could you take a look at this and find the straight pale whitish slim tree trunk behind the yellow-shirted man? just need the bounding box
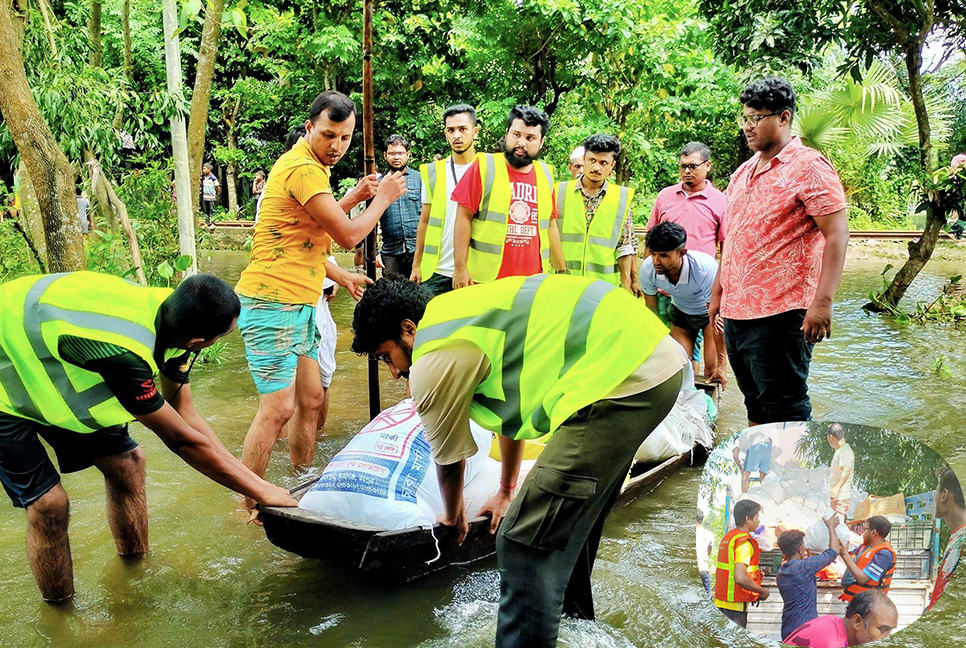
[161,0,200,274]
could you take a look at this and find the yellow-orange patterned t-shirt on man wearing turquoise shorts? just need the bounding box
[235,138,332,306]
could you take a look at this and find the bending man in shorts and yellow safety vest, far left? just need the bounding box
[0,272,296,603]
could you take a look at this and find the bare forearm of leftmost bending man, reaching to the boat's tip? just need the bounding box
[136,404,298,506]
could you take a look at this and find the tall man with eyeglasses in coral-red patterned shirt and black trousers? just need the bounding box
[708,77,849,425]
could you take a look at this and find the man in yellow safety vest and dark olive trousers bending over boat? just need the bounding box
[352,274,687,648]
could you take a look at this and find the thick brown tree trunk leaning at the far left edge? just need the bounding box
[0,1,84,272]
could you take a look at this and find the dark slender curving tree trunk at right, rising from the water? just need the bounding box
[865,39,946,312]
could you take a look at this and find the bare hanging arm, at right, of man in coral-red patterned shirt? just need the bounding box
[802,209,849,344]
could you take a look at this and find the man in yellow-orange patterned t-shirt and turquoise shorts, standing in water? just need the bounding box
[235,91,406,498]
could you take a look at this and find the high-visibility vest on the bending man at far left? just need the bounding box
[0,272,172,433]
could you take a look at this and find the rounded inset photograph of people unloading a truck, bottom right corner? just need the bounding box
[695,421,966,648]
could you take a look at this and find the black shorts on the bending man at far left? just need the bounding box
[0,413,138,508]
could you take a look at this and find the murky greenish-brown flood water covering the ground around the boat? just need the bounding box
[0,253,966,648]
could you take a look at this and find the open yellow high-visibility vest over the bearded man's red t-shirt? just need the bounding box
[466,153,553,283]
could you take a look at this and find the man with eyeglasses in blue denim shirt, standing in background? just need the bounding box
[379,134,423,279]
